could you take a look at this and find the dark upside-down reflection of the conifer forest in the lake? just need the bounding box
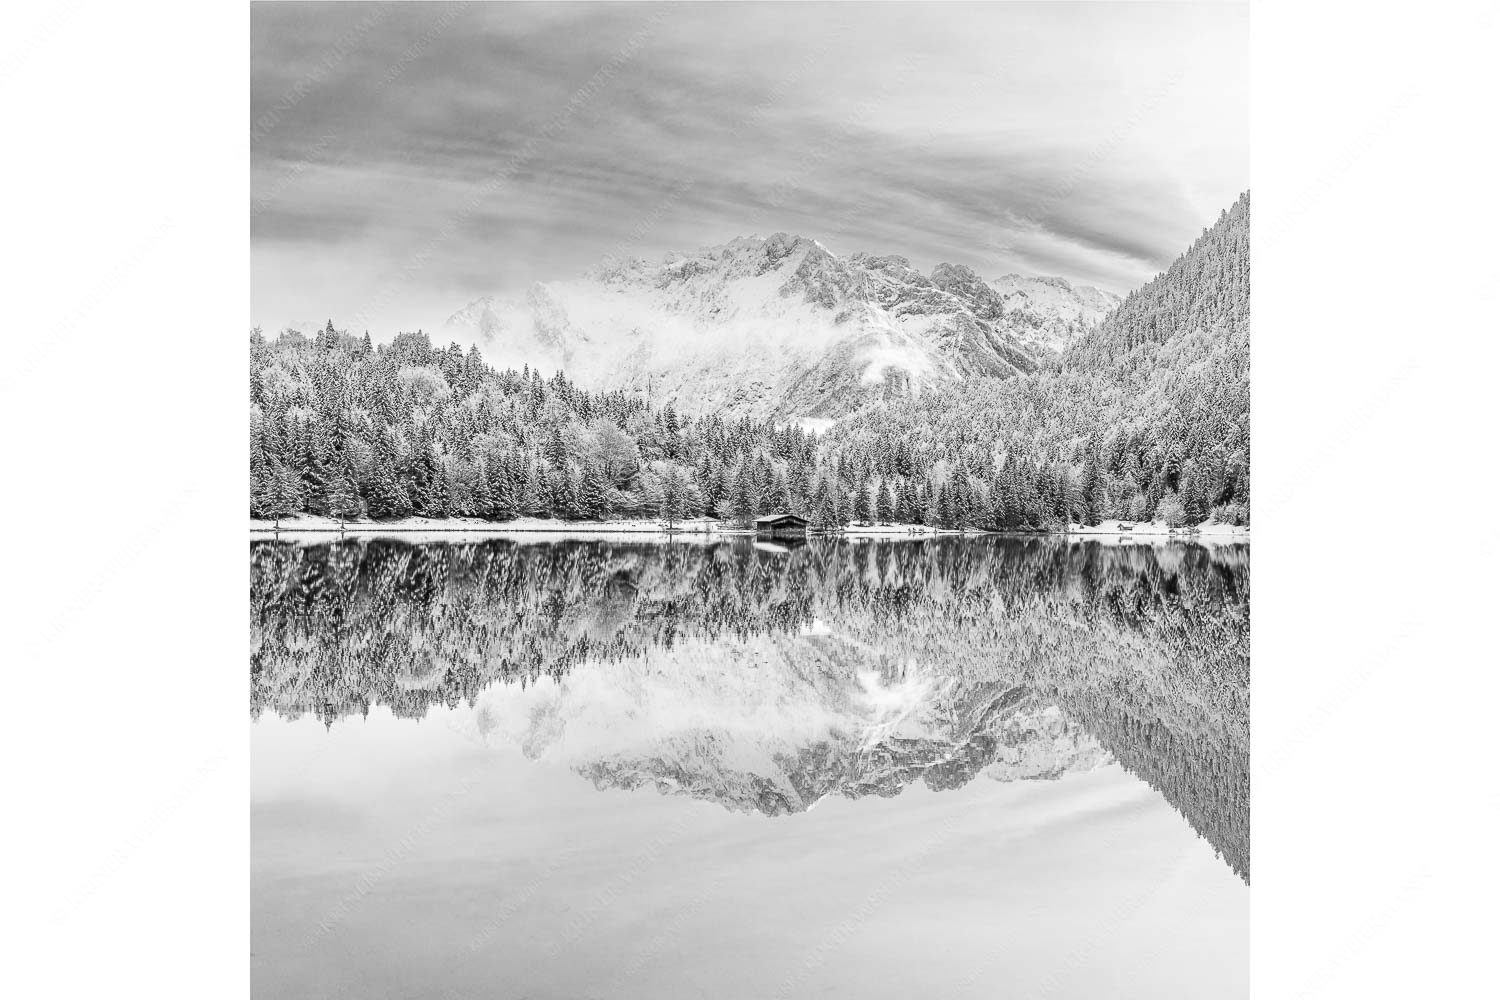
[251,538,1250,874]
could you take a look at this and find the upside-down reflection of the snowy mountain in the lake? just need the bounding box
[462,634,1113,816]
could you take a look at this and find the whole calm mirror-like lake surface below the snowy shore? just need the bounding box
[251,537,1250,1000]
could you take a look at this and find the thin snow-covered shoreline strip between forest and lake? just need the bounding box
[251,516,1250,544]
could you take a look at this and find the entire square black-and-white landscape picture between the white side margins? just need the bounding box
[249,3,1251,999]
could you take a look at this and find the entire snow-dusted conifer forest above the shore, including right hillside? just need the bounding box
[251,192,1250,529]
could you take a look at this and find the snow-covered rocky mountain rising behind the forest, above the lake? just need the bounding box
[440,232,1119,421]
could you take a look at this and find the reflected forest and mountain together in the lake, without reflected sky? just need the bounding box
[251,537,1250,882]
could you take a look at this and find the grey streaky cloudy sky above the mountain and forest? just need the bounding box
[251,3,1250,339]
